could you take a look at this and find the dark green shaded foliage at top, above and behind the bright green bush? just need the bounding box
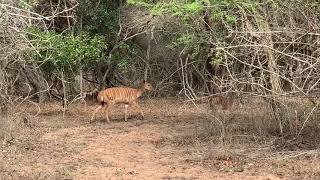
[74,0,132,67]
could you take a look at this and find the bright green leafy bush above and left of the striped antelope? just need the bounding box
[27,28,106,72]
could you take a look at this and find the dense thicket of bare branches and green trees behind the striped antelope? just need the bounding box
[0,0,320,143]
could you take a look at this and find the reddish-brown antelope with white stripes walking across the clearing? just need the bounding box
[90,80,153,123]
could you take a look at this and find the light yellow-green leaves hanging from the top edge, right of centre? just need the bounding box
[128,0,281,64]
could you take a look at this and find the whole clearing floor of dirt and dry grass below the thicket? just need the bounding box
[0,99,320,179]
